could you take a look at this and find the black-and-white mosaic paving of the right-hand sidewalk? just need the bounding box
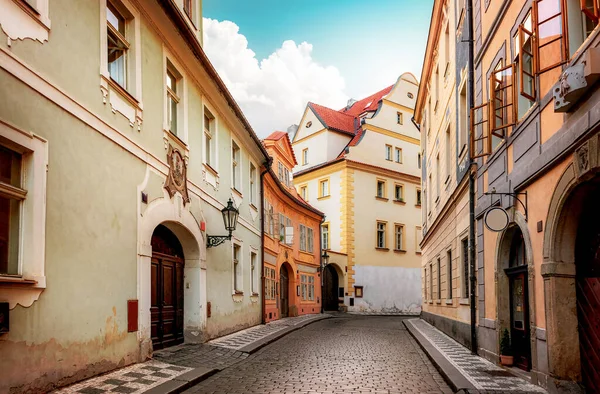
[406,319,546,394]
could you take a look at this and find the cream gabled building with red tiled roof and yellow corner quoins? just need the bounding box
[292,73,421,312]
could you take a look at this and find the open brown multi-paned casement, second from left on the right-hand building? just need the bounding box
[490,63,517,138]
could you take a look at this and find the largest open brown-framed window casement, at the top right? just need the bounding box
[533,0,568,74]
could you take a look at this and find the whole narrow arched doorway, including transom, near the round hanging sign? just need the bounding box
[504,227,531,371]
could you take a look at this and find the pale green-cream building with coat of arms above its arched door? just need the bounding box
[0,0,267,392]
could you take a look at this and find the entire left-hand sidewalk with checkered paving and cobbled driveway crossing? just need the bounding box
[53,314,331,394]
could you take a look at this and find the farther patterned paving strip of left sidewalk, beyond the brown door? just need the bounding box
[208,314,323,350]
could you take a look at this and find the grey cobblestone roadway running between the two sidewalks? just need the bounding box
[187,315,452,394]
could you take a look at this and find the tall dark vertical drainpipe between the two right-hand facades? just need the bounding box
[467,0,477,354]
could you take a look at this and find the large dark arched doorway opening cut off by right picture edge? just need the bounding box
[575,180,600,393]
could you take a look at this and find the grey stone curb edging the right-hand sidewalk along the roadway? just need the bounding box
[402,319,478,393]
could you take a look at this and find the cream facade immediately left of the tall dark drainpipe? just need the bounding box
[415,1,471,346]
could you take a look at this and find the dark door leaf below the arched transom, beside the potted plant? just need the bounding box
[507,266,531,371]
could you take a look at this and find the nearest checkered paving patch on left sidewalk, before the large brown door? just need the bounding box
[52,360,192,394]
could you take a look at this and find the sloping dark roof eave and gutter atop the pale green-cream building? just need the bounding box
[157,0,269,163]
